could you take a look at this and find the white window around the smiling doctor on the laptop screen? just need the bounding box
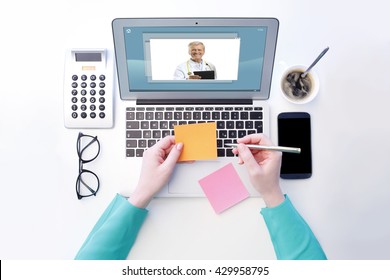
[145,37,240,82]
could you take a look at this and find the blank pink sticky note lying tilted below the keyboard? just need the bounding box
[199,163,249,214]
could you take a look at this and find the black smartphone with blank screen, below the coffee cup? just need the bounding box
[278,112,312,179]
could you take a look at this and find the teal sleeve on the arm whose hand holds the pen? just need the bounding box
[261,196,326,260]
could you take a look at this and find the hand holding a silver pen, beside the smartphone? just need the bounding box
[233,134,284,207]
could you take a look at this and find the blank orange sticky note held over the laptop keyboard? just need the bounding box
[174,122,217,161]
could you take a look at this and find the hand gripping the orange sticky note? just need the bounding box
[129,136,183,208]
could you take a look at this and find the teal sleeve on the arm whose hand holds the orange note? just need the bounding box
[75,194,148,260]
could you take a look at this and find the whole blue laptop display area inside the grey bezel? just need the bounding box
[123,26,267,92]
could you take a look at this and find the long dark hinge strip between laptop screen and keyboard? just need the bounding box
[137,99,253,105]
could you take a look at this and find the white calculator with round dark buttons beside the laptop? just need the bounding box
[64,48,114,128]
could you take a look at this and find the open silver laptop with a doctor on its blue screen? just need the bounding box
[112,18,279,197]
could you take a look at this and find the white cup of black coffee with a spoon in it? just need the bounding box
[280,65,320,104]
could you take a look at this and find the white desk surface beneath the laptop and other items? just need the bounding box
[0,0,390,259]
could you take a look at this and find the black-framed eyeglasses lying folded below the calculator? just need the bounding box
[76,132,100,199]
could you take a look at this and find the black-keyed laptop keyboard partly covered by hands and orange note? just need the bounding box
[126,105,263,157]
